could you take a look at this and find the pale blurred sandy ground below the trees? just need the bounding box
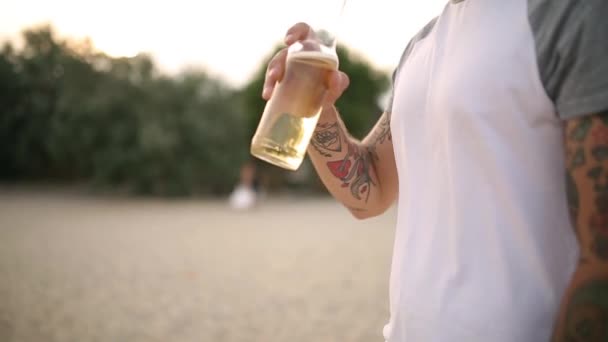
[0,189,395,342]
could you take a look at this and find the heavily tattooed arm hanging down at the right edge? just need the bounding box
[554,111,608,342]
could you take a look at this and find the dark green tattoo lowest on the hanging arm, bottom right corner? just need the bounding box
[556,278,608,342]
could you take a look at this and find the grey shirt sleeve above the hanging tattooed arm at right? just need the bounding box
[528,0,608,119]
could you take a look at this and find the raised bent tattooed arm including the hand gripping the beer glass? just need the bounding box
[262,23,397,219]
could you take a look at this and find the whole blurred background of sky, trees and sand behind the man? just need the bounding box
[0,0,444,341]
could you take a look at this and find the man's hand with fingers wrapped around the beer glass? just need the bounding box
[262,23,349,107]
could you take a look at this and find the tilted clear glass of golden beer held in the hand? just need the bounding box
[251,51,338,170]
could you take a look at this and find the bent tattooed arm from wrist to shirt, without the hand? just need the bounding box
[308,106,397,219]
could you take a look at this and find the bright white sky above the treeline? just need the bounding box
[0,0,447,86]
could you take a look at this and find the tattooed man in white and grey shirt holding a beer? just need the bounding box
[263,0,608,342]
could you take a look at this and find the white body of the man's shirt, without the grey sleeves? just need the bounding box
[384,0,579,342]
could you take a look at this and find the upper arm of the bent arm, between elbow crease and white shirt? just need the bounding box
[362,113,399,206]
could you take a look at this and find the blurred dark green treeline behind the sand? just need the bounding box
[0,26,388,196]
